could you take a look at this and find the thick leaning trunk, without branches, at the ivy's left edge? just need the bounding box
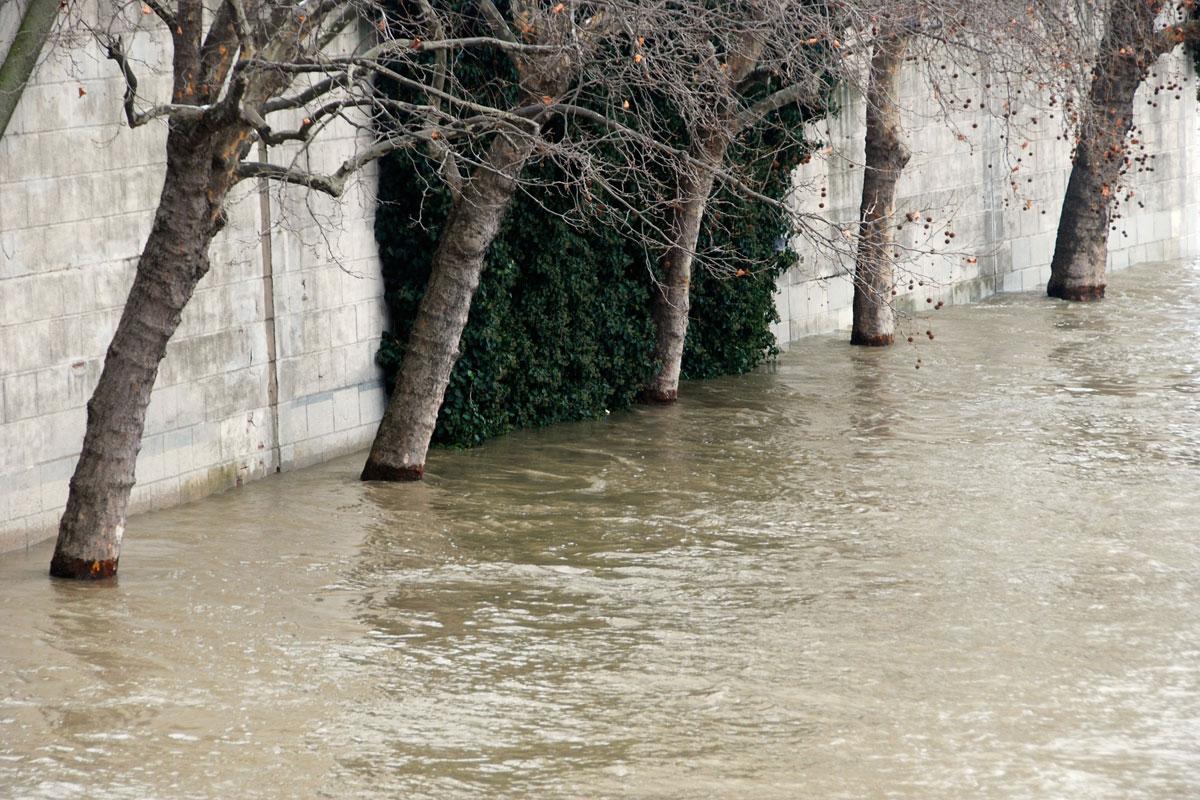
[362,134,534,481]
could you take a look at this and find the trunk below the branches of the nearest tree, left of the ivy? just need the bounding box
[50,130,228,578]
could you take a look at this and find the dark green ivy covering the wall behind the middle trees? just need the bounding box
[376,92,820,446]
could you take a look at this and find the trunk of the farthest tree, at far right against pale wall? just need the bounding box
[1046,1,1162,301]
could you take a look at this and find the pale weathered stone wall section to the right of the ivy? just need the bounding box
[775,48,1200,342]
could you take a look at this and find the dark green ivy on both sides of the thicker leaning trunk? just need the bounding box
[376,160,654,446]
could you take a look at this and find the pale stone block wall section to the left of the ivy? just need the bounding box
[0,20,384,552]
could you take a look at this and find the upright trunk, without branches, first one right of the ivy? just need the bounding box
[850,35,911,347]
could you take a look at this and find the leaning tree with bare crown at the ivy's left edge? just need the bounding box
[362,0,643,481]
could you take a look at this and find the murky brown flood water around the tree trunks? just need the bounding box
[0,265,1200,800]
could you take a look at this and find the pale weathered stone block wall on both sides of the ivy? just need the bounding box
[0,23,1200,552]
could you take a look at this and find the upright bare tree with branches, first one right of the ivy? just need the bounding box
[847,0,1086,347]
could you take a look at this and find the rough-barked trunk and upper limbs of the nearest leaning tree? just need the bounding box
[50,0,274,579]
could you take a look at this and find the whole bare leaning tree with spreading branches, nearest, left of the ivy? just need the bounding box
[50,0,549,578]
